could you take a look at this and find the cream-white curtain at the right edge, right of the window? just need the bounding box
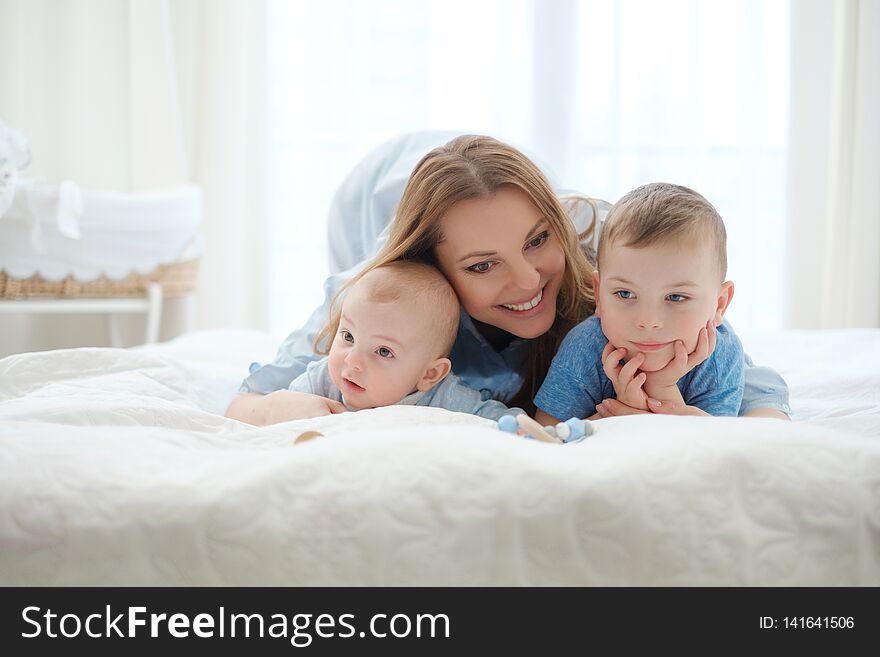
[788,0,880,328]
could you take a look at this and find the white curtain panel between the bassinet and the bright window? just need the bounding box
[170,0,269,328]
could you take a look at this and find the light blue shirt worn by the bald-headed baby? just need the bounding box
[288,358,522,420]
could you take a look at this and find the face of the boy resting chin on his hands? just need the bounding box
[594,243,723,372]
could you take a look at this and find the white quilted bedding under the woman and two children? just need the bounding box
[0,331,880,586]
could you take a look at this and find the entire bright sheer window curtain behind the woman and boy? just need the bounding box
[269,0,789,332]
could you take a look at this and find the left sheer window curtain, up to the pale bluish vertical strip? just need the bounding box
[269,0,532,333]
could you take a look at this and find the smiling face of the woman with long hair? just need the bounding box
[436,186,565,338]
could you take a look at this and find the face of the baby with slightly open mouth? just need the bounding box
[328,285,440,410]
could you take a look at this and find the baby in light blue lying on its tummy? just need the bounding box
[289,262,519,420]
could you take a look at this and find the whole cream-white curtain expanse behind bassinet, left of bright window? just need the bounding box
[0,0,267,354]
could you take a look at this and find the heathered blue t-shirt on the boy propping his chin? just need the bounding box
[535,315,744,420]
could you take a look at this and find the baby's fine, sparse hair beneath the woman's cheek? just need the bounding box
[359,260,461,357]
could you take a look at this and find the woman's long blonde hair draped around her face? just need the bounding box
[315,135,598,412]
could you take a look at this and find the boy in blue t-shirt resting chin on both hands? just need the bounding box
[535,183,743,424]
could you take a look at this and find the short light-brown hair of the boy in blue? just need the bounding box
[598,183,727,281]
